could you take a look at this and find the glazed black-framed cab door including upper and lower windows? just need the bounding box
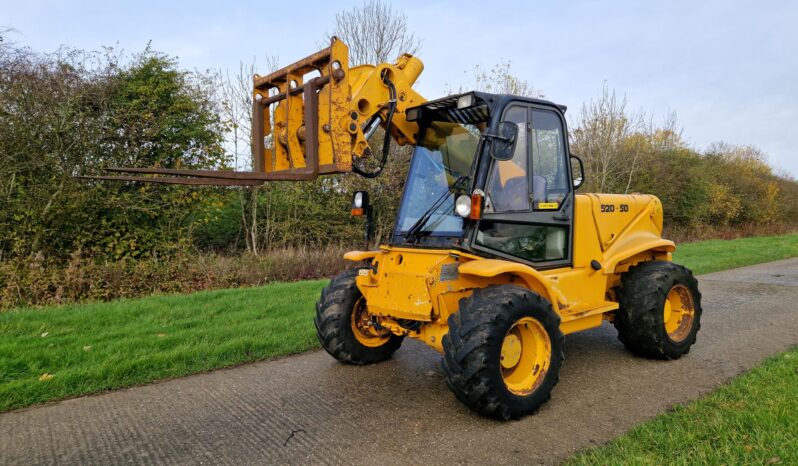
[472,103,574,268]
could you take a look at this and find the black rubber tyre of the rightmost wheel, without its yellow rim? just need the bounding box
[614,261,702,359]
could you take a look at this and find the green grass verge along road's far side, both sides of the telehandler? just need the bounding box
[0,235,798,412]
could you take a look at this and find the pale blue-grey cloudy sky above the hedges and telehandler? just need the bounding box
[6,0,798,177]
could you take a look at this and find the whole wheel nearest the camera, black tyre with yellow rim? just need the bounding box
[442,285,564,420]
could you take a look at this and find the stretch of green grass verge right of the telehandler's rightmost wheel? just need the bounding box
[673,233,798,275]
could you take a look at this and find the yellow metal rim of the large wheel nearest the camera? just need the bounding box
[501,317,551,395]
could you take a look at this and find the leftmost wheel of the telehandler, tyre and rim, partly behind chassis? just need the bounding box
[314,269,403,364]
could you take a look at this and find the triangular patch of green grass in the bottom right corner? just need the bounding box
[565,348,798,465]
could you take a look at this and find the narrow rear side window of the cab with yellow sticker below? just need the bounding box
[529,109,570,209]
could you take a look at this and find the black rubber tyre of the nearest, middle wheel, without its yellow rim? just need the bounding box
[442,285,565,420]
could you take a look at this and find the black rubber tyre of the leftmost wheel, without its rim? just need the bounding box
[313,269,404,365]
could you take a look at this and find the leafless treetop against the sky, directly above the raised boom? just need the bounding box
[328,0,421,66]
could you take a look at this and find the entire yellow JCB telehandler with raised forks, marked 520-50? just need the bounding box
[99,38,701,419]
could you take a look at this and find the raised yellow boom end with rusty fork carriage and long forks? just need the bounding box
[84,37,426,186]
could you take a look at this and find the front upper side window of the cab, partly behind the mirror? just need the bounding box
[485,106,529,212]
